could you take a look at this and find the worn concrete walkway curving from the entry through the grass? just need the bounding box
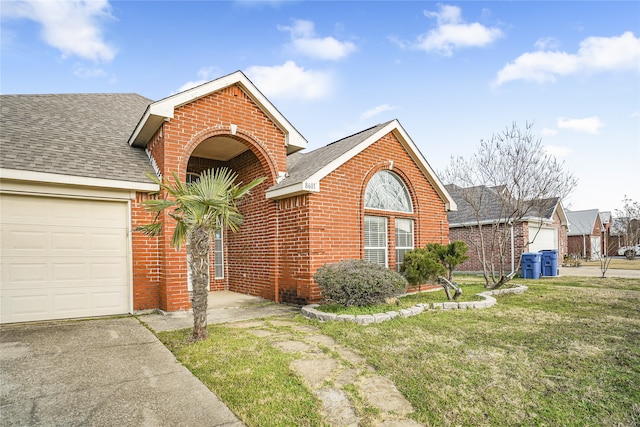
[139,292,421,427]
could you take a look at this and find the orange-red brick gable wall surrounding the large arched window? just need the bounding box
[278,133,449,302]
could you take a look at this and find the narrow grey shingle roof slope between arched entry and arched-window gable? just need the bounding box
[270,121,391,190]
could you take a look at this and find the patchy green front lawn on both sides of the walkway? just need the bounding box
[159,277,640,426]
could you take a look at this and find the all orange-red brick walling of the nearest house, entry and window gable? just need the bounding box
[133,86,449,311]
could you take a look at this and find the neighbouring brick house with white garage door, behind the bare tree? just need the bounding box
[446,184,568,272]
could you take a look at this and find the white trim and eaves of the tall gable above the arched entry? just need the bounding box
[129,71,307,153]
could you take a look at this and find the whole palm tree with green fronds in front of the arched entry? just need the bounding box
[136,168,265,341]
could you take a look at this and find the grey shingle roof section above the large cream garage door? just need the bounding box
[0,94,157,190]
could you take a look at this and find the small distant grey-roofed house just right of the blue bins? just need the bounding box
[567,209,603,260]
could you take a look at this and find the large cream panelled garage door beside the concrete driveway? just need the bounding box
[0,194,130,323]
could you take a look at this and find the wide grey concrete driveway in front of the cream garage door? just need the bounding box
[0,317,244,427]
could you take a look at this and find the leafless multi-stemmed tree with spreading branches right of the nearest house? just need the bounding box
[442,123,577,288]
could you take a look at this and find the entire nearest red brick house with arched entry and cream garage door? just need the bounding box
[0,72,455,322]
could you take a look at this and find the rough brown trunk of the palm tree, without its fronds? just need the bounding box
[188,226,211,341]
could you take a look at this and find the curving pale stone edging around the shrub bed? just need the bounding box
[302,285,529,325]
